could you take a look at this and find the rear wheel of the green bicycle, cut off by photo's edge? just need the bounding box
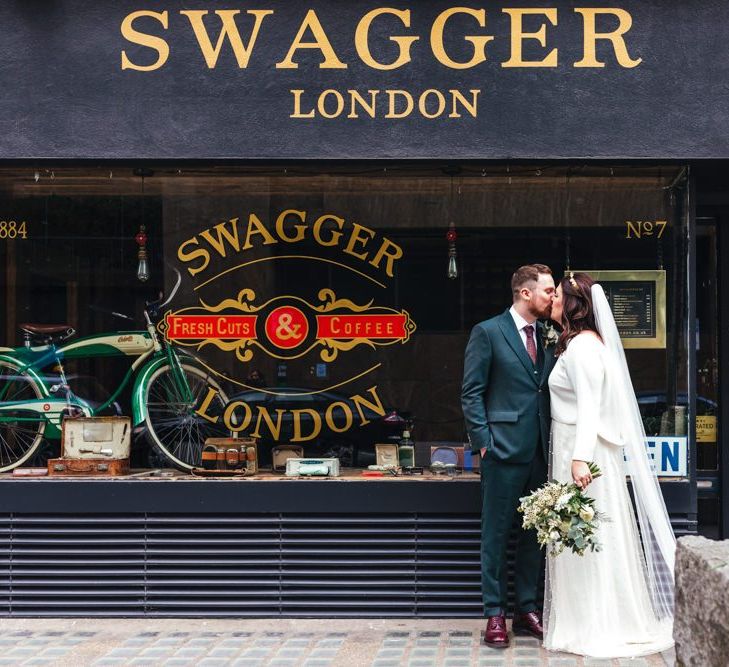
[0,359,46,472]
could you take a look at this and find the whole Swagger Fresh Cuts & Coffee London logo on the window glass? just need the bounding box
[158,209,416,442]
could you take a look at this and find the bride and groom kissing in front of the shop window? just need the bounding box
[461,264,675,658]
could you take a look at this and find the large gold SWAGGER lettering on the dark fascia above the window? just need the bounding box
[119,6,642,71]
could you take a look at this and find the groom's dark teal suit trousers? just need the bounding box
[481,444,547,617]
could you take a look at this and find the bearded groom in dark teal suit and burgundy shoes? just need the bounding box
[461,264,555,648]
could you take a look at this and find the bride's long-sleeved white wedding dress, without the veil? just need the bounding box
[544,332,673,658]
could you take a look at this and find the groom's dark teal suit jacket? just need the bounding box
[461,310,555,463]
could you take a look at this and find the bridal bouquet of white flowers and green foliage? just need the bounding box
[519,463,608,556]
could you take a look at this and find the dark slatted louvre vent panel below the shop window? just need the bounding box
[0,514,695,618]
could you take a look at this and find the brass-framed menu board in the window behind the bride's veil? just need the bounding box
[575,270,666,348]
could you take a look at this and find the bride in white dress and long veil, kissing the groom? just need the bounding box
[544,273,676,658]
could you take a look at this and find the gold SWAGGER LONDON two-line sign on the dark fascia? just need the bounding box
[119,3,642,122]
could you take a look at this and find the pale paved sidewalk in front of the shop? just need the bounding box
[0,619,675,667]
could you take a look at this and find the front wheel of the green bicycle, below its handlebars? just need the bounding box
[144,362,231,470]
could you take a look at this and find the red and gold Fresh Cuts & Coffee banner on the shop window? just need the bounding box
[159,289,416,362]
